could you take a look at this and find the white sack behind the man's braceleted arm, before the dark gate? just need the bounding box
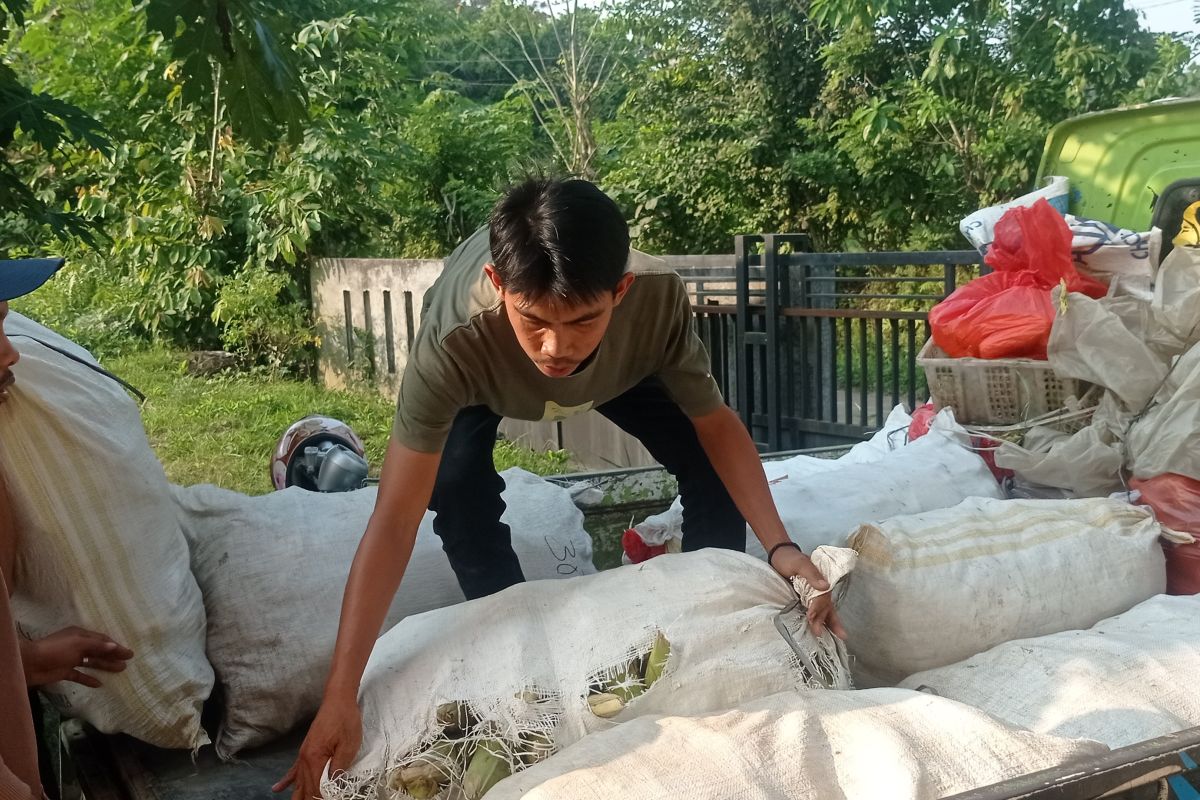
[634,415,1004,559]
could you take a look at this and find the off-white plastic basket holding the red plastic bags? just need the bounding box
[917,339,1091,425]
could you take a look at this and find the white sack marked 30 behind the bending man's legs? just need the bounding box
[173,469,595,758]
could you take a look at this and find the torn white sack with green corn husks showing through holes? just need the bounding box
[323,548,852,800]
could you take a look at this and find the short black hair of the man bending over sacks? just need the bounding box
[488,178,629,305]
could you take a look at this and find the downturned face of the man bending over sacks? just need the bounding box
[484,264,634,378]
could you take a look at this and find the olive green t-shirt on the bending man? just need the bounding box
[392,228,724,452]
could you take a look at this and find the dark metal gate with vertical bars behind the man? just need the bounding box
[676,234,983,452]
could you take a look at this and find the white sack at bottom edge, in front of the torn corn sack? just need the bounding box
[487,688,1105,800]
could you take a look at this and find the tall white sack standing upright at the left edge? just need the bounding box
[0,313,212,748]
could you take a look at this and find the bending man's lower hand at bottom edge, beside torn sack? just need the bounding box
[271,697,362,800]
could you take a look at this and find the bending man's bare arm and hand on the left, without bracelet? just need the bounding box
[275,438,442,800]
